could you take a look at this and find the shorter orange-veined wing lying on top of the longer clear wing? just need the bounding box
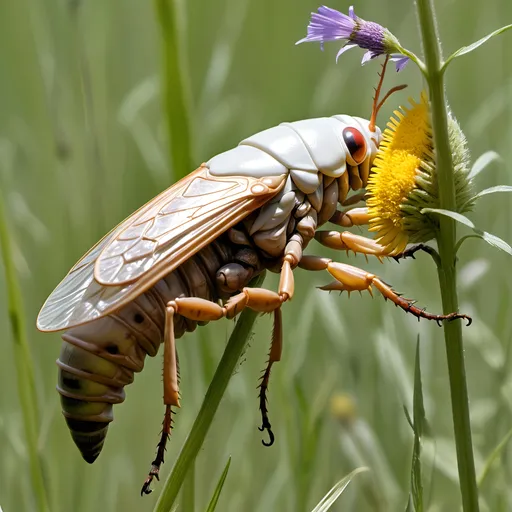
[94,167,284,286]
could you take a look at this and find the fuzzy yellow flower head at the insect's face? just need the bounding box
[366,93,471,255]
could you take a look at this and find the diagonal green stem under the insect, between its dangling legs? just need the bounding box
[154,275,265,512]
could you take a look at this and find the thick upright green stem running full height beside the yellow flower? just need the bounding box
[417,0,479,512]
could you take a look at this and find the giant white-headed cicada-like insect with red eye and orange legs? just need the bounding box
[37,62,463,493]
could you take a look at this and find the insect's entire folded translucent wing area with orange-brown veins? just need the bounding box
[37,167,286,331]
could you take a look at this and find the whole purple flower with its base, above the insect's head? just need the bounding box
[296,6,409,71]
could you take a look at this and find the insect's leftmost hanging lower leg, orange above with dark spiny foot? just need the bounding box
[140,302,180,496]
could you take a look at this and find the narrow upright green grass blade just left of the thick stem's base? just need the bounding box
[411,336,425,512]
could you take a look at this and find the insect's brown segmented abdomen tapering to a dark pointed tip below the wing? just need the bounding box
[57,240,232,463]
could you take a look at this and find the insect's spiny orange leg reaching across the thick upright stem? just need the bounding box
[299,256,471,325]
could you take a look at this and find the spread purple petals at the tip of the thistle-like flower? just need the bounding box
[296,6,356,44]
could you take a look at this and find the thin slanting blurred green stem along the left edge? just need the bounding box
[0,194,50,512]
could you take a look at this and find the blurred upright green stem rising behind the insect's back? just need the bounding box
[155,0,193,181]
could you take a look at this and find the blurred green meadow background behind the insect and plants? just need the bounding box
[0,0,512,512]
